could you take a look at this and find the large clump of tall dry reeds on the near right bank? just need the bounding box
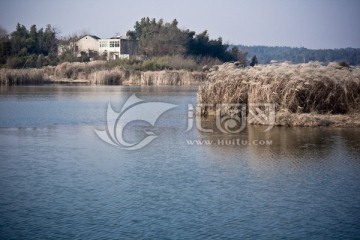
[198,62,360,126]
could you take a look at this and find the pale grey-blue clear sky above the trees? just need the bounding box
[0,0,360,49]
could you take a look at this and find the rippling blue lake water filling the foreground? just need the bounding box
[0,85,360,239]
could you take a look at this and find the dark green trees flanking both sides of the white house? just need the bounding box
[0,17,246,68]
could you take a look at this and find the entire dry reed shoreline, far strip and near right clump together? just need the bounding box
[0,62,360,128]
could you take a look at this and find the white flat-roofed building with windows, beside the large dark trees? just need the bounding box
[99,37,137,60]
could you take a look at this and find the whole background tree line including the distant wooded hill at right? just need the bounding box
[0,17,360,68]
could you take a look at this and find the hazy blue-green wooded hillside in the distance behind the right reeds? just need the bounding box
[237,45,360,65]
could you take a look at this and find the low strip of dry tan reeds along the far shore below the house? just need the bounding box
[0,57,206,85]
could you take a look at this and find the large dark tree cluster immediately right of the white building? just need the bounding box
[127,17,246,65]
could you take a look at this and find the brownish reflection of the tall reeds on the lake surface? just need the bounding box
[197,117,360,170]
